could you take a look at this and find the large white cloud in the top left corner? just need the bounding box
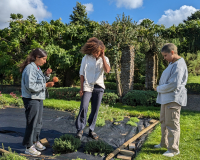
[0,0,51,29]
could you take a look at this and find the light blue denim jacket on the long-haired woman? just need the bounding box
[21,62,50,100]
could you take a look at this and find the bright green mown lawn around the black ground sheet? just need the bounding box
[0,95,200,160]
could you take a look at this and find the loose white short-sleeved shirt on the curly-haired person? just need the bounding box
[79,54,110,92]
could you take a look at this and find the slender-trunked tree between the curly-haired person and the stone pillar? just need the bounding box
[94,14,137,97]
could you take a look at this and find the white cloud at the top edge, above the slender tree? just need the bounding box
[114,0,143,9]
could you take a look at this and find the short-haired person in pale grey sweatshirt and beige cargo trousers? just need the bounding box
[154,43,188,157]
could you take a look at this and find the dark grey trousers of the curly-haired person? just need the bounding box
[75,85,104,131]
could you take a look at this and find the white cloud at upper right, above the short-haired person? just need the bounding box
[158,5,198,27]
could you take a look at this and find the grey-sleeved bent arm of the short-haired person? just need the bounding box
[157,68,184,93]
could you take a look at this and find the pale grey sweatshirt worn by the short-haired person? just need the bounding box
[156,58,188,106]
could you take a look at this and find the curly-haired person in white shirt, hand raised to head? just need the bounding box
[75,37,110,139]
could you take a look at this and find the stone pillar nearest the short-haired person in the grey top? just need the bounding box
[145,50,157,90]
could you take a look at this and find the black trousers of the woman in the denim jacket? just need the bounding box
[22,98,43,147]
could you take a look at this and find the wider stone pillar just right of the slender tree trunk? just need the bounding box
[121,46,135,96]
